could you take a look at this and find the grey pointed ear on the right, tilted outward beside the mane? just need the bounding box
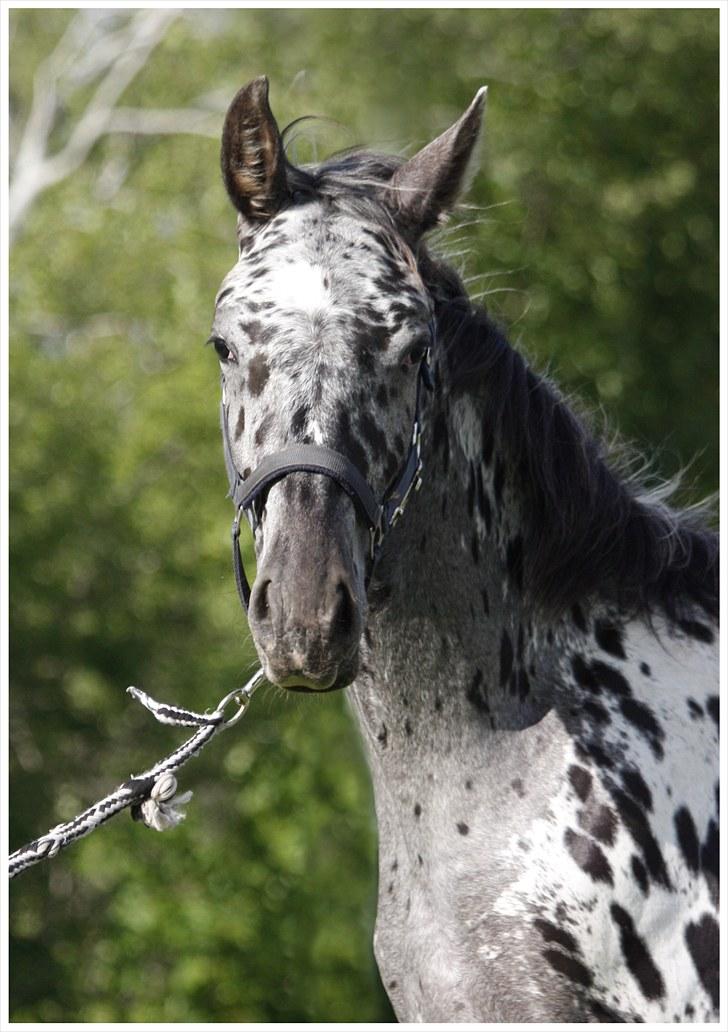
[386,86,487,237]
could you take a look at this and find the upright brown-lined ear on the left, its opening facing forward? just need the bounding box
[220,75,289,222]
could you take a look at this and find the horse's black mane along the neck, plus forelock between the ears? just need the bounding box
[297,152,719,620]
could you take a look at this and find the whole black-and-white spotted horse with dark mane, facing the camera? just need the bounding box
[211,77,719,1023]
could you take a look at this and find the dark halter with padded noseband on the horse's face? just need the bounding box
[220,348,433,612]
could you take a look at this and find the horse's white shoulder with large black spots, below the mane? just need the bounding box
[512,606,719,1021]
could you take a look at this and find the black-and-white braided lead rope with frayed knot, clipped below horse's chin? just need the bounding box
[8,670,265,878]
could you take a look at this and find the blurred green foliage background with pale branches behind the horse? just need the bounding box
[9,9,719,1023]
